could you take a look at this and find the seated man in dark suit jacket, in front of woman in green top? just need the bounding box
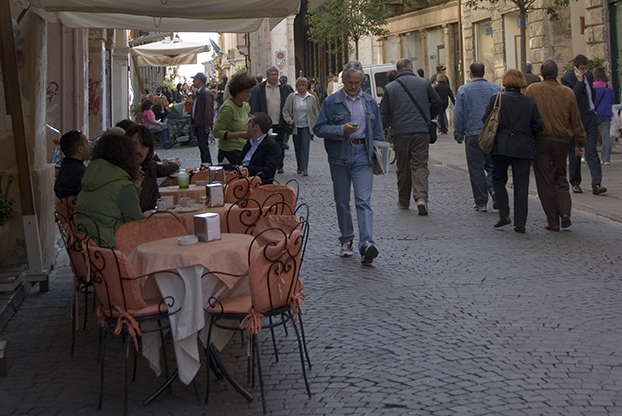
[238,112,281,183]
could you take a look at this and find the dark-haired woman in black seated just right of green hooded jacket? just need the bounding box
[125,124,179,212]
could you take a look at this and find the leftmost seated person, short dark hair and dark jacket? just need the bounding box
[54,130,91,199]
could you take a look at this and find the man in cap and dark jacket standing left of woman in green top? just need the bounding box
[192,72,214,165]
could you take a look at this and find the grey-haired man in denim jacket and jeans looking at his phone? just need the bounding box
[313,61,384,265]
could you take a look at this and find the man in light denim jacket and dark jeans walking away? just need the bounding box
[454,61,503,212]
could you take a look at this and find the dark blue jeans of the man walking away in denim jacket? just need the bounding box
[464,136,494,205]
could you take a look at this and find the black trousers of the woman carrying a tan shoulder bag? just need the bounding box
[492,155,531,227]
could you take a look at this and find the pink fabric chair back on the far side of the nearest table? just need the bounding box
[114,217,188,256]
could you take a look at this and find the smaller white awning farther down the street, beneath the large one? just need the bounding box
[131,41,211,66]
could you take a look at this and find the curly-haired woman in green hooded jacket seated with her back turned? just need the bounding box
[76,134,145,247]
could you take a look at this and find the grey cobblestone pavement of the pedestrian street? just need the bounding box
[0,140,622,416]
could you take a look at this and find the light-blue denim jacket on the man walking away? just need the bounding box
[454,78,501,142]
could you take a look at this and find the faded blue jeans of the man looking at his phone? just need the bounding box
[330,144,375,252]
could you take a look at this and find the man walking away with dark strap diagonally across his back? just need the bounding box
[380,58,442,215]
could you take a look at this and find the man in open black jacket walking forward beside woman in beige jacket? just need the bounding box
[251,66,294,173]
